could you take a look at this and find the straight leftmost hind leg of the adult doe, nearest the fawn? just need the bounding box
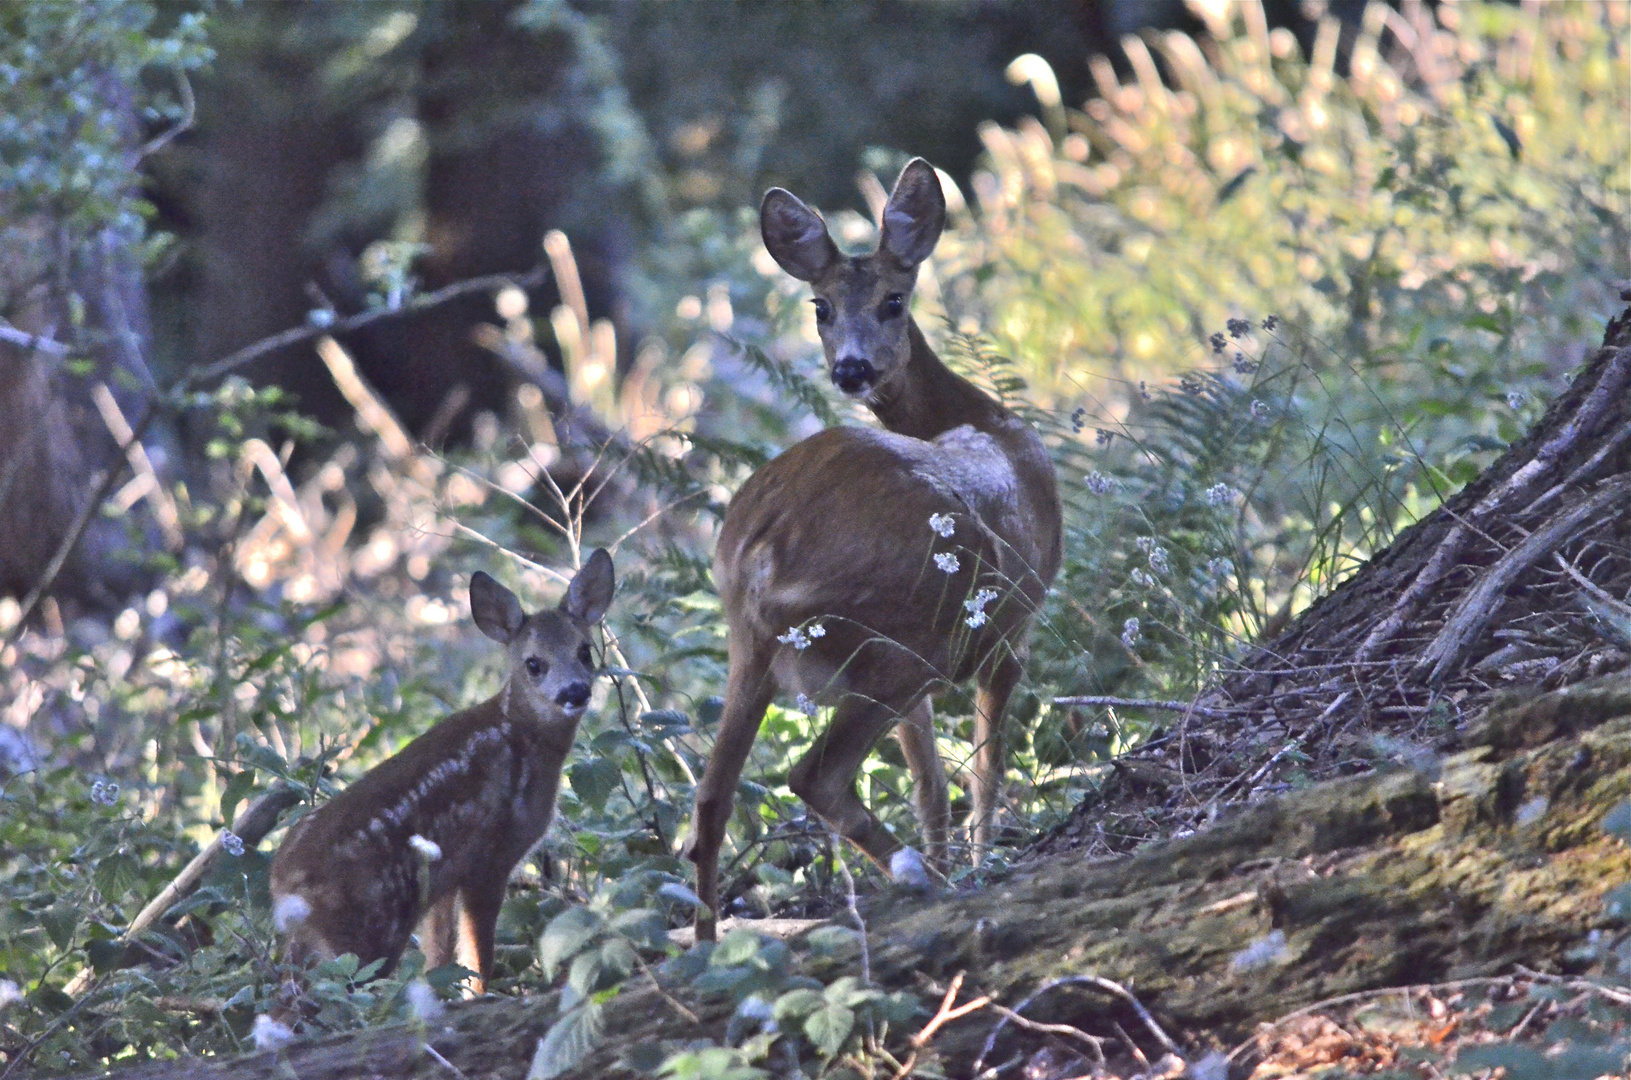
[685,656,775,941]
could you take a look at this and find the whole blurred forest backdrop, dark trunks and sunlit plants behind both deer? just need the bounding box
[0,0,1631,1069]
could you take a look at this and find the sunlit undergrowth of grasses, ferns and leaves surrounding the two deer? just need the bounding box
[0,5,1631,1077]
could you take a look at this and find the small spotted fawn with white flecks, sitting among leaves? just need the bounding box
[272,551,613,994]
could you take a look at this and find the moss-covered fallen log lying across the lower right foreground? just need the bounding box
[101,674,1631,1080]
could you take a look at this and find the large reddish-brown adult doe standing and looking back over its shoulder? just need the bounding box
[687,158,1060,940]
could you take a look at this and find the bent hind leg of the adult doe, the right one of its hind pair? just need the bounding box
[788,695,900,873]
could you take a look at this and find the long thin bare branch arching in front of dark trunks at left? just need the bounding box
[0,268,546,644]
